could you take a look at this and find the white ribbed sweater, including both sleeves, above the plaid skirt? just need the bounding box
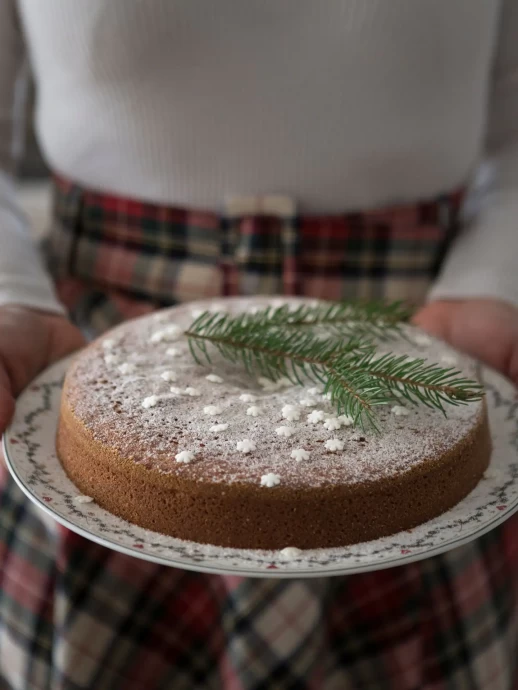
[0,0,518,309]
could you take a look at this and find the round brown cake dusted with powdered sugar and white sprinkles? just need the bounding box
[57,298,491,550]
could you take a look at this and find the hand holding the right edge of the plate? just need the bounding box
[413,299,518,385]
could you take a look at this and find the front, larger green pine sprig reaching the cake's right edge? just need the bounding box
[186,312,483,428]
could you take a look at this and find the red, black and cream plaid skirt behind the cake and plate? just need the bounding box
[0,181,518,690]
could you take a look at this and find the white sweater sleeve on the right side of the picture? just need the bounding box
[429,0,518,305]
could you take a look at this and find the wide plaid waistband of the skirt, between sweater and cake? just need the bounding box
[49,177,463,304]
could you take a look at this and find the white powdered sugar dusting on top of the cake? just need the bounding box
[68,298,483,487]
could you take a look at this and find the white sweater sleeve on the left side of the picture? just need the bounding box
[0,0,64,313]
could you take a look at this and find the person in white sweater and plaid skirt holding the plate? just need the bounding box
[0,0,518,690]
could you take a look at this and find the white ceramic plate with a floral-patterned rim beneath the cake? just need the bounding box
[3,360,518,577]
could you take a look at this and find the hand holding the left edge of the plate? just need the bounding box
[0,306,85,436]
